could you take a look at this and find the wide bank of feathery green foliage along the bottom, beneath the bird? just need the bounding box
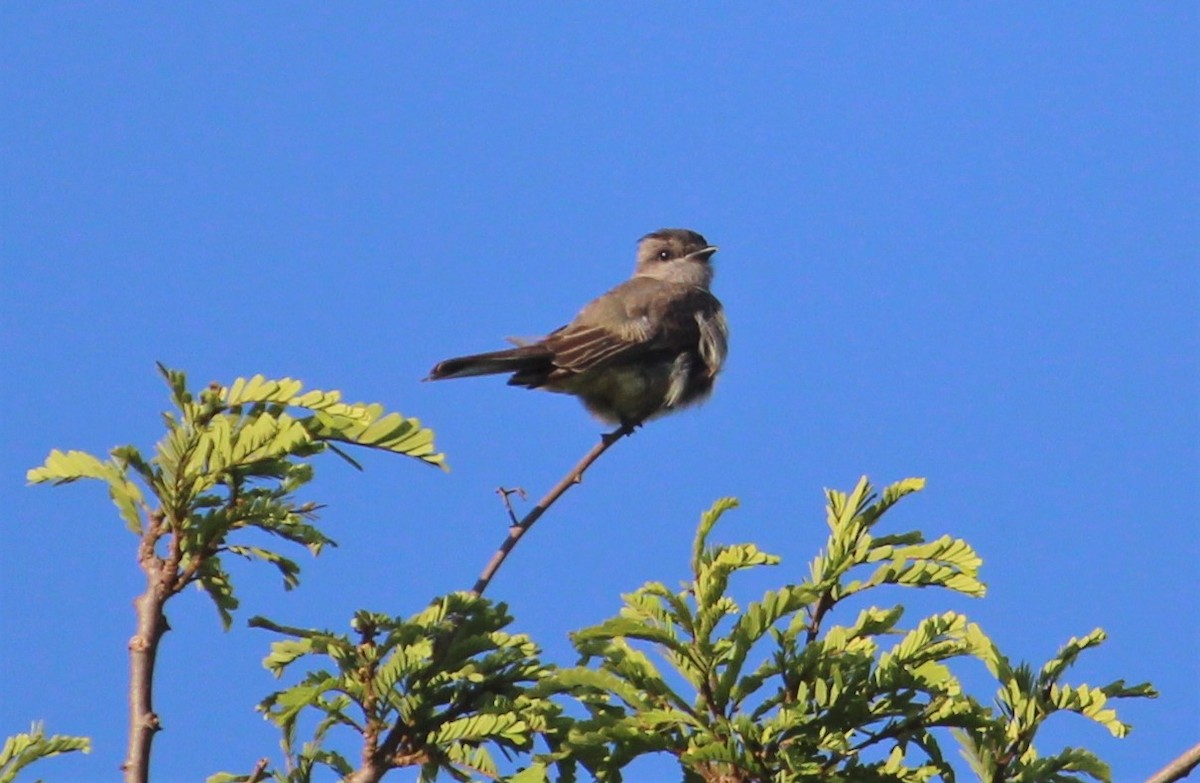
[231,478,1153,783]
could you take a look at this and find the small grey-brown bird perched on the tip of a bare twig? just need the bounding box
[426,228,728,426]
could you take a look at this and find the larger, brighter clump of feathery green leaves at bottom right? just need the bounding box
[537,478,1148,783]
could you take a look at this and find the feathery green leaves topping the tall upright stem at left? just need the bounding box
[28,365,445,627]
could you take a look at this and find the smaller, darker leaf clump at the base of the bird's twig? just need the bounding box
[225,593,558,783]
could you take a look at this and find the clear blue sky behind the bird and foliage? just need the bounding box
[0,2,1200,781]
